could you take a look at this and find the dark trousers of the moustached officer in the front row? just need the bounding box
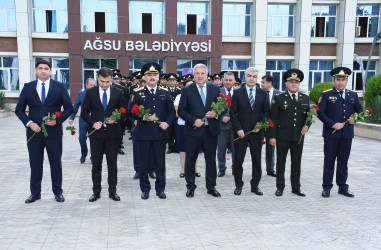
[136,140,166,192]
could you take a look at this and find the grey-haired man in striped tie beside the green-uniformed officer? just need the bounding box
[230,67,270,195]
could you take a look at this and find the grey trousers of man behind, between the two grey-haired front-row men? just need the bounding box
[217,128,235,171]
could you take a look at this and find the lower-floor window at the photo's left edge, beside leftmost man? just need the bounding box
[0,57,19,91]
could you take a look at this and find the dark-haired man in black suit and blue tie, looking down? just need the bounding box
[81,68,126,202]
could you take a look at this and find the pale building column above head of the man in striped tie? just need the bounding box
[250,0,268,75]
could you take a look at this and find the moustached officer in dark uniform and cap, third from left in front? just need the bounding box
[128,63,175,200]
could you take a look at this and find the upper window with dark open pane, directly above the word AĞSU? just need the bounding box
[81,0,118,33]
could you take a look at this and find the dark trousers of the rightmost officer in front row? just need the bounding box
[323,138,352,190]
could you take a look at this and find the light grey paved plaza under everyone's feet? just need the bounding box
[0,113,381,249]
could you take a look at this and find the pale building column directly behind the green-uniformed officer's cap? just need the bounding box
[295,0,312,91]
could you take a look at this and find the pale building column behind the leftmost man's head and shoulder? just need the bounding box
[15,0,34,91]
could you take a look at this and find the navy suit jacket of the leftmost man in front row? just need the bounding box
[15,79,73,138]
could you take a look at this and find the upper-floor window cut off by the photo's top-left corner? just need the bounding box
[0,0,16,31]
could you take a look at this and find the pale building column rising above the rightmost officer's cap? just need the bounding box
[336,0,357,88]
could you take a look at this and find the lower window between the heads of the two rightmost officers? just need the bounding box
[308,60,333,90]
